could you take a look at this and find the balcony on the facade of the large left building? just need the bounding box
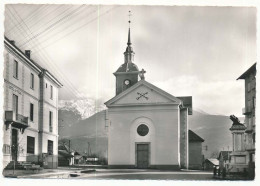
[5,111,29,133]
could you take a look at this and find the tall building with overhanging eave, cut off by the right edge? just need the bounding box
[237,63,256,179]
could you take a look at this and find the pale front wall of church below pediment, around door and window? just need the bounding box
[108,105,179,168]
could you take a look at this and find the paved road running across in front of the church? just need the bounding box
[75,169,214,180]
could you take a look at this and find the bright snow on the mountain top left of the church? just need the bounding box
[59,99,106,119]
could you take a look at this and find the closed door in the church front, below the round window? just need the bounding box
[136,144,149,169]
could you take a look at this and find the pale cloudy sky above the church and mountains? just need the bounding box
[5,4,256,116]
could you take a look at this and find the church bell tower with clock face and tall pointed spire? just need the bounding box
[114,11,143,95]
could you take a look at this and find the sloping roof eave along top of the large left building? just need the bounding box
[4,37,63,87]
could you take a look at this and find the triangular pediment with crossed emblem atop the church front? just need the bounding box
[105,80,181,107]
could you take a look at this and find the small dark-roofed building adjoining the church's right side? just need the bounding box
[189,130,204,169]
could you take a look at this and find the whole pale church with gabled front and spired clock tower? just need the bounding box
[105,21,192,170]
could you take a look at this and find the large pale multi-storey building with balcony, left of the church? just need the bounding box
[3,38,62,168]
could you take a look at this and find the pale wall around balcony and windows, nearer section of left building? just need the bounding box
[3,48,39,167]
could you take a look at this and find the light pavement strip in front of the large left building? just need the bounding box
[3,167,95,178]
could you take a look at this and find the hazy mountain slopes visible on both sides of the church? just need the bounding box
[59,99,242,158]
